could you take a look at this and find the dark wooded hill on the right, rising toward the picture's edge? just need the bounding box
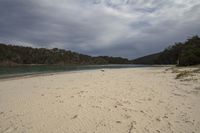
[132,36,200,66]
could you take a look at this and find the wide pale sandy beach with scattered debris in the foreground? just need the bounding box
[0,67,200,133]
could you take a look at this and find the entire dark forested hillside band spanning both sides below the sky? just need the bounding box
[0,36,200,66]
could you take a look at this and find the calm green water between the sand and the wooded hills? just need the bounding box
[0,64,146,78]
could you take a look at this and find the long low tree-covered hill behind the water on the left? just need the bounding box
[0,44,131,65]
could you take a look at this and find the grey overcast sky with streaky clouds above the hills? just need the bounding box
[0,0,200,59]
